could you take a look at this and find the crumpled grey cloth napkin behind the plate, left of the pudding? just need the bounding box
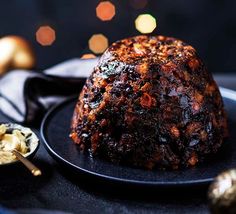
[0,58,98,123]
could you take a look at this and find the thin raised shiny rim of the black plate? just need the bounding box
[40,95,236,187]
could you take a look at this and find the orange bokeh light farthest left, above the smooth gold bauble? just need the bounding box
[36,26,56,46]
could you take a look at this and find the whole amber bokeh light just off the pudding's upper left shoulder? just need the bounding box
[89,34,108,54]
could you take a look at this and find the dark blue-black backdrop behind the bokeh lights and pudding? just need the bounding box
[0,0,236,73]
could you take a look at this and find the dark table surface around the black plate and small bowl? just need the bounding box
[0,74,236,213]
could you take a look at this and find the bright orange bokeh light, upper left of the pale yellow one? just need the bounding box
[96,1,116,21]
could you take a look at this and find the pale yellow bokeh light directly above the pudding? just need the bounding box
[135,14,157,33]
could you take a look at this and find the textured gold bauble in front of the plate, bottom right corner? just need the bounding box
[208,169,236,214]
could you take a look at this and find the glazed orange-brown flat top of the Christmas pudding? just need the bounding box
[102,35,196,64]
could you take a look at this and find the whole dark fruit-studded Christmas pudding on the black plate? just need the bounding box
[70,36,227,169]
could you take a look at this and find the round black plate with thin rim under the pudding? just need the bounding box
[41,93,236,186]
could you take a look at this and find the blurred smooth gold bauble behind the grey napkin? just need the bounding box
[0,36,35,76]
